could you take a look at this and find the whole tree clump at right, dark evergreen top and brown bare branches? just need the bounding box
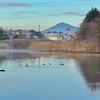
[76,7,100,43]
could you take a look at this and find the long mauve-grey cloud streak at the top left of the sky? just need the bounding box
[0,2,33,7]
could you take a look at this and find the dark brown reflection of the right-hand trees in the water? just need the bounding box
[78,56,100,91]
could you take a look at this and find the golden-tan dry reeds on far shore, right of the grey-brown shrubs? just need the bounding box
[27,41,100,52]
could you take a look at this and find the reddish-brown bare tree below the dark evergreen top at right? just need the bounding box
[76,22,98,42]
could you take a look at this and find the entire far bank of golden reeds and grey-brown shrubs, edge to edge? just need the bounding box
[0,39,100,52]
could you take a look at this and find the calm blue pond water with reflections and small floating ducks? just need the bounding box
[0,50,100,100]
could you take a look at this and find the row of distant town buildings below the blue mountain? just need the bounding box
[3,29,75,40]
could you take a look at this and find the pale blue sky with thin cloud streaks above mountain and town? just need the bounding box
[0,0,100,31]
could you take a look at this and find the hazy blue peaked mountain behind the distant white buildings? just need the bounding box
[43,22,79,34]
